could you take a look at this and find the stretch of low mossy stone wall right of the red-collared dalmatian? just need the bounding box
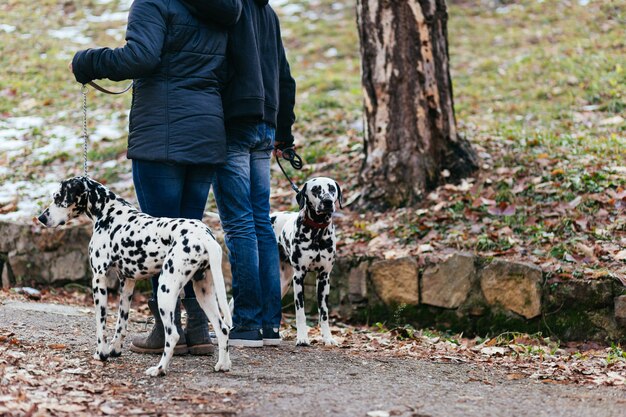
[307,253,626,342]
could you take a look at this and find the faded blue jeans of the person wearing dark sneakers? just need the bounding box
[213,122,281,330]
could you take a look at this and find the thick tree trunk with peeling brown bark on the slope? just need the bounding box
[357,0,478,208]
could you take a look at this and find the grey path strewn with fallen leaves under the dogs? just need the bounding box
[0,301,626,417]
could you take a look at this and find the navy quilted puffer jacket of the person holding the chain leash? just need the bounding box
[72,0,242,164]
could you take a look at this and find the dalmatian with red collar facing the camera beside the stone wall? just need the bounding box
[271,177,342,346]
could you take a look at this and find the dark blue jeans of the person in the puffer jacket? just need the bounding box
[133,159,215,299]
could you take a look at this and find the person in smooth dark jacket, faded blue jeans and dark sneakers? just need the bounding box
[187,0,296,347]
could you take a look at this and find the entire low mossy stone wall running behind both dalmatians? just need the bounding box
[0,222,626,342]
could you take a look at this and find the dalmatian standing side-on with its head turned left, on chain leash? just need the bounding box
[38,177,232,376]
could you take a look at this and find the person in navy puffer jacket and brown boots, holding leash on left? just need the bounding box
[70,0,242,354]
